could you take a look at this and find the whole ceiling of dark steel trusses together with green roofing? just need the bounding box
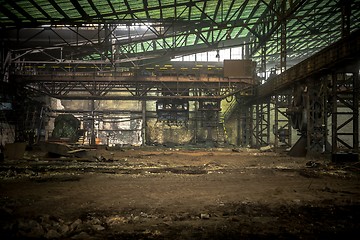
[0,0,360,71]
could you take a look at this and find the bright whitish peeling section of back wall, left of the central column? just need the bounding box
[46,99,143,146]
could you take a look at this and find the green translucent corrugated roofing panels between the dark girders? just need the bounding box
[0,0,360,66]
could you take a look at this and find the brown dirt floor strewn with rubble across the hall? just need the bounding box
[0,147,360,239]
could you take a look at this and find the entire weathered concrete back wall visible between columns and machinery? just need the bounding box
[46,99,360,146]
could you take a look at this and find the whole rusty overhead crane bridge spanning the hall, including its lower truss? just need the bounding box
[12,63,257,101]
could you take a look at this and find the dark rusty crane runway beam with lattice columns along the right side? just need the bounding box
[247,31,360,156]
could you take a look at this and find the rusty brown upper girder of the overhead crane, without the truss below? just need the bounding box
[14,62,253,84]
